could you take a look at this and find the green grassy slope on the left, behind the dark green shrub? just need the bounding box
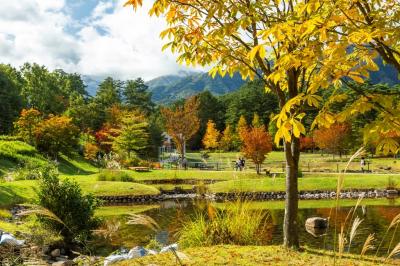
[0,141,160,207]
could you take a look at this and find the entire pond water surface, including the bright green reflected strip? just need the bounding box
[94,199,400,255]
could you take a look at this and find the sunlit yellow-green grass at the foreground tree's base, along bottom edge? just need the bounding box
[116,245,399,266]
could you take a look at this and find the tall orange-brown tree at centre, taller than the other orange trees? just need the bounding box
[161,97,200,157]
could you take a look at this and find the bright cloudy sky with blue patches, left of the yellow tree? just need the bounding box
[0,0,196,80]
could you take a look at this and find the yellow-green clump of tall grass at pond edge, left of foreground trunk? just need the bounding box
[179,201,267,247]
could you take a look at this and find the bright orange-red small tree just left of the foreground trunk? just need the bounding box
[242,126,272,174]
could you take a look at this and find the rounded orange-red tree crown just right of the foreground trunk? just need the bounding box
[314,123,351,156]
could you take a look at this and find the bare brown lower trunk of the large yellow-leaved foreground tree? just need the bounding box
[283,136,300,249]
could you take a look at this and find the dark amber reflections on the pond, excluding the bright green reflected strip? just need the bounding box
[99,200,400,254]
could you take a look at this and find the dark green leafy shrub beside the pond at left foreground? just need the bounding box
[37,166,99,245]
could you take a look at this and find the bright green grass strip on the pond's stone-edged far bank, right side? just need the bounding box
[208,174,400,192]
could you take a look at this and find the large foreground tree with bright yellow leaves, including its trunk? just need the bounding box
[126,0,397,248]
